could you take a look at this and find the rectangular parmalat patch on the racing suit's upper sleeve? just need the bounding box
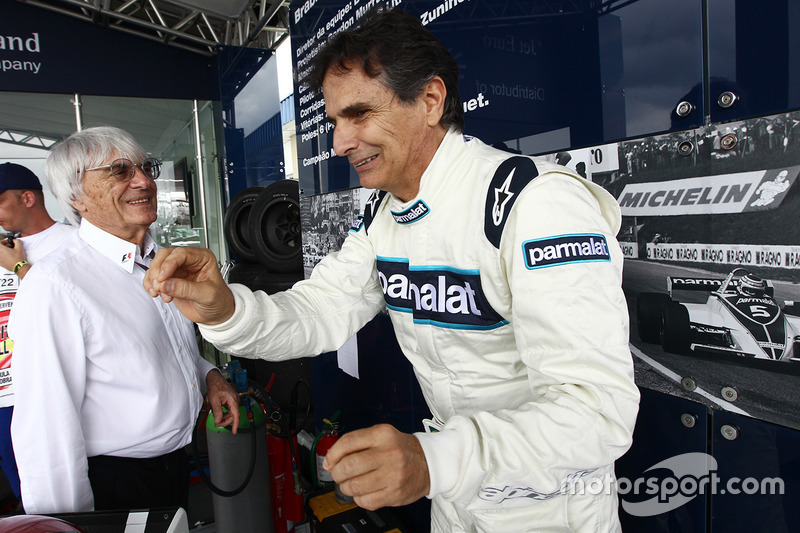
[522,233,611,269]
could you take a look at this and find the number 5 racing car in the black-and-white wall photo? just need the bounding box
[636,268,800,362]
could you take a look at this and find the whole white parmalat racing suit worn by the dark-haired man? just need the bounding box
[201,132,639,532]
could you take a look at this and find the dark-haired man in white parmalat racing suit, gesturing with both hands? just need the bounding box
[144,6,639,532]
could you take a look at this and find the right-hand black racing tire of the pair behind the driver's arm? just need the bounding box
[250,180,303,273]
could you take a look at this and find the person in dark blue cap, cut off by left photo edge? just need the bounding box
[0,163,74,510]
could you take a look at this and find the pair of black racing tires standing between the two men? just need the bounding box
[224,180,303,293]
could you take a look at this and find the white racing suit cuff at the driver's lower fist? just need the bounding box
[414,429,464,498]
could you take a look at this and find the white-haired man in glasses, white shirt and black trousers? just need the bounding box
[9,127,239,514]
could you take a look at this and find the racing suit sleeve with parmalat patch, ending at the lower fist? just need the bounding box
[416,174,639,508]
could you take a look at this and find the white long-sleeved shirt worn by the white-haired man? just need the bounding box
[9,220,215,513]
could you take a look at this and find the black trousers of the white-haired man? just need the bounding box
[89,448,189,512]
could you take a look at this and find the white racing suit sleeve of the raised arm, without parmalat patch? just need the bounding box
[200,228,384,360]
